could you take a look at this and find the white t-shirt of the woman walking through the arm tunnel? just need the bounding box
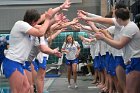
[62,41,80,60]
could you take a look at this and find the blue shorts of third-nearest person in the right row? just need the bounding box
[108,54,116,76]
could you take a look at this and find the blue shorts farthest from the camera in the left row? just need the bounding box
[33,57,47,72]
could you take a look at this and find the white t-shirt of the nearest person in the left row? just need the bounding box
[6,21,32,63]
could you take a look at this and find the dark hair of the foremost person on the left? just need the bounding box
[23,9,40,25]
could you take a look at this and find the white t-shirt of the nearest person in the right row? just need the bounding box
[122,22,140,60]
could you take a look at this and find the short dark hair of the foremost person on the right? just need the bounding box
[115,8,130,21]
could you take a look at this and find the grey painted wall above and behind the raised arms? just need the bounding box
[0,0,100,33]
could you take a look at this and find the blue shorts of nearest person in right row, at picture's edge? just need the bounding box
[126,58,140,74]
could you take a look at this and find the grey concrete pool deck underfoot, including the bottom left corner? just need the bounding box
[0,64,99,93]
